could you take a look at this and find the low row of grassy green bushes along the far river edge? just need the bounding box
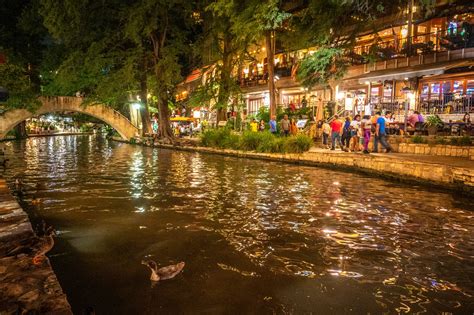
[201,128,313,153]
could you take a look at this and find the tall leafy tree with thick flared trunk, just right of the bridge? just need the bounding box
[124,0,199,139]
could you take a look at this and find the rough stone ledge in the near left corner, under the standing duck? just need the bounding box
[0,179,72,314]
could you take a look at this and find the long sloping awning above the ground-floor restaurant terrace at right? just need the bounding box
[350,59,474,84]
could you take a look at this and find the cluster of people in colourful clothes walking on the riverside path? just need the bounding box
[322,112,392,154]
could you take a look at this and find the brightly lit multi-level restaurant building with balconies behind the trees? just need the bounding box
[177,1,474,121]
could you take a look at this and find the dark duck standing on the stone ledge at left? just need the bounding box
[7,227,56,265]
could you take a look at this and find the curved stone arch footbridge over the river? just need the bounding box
[0,96,139,140]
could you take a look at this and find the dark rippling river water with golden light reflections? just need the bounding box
[5,136,474,314]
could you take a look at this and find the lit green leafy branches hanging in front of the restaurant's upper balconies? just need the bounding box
[291,0,433,88]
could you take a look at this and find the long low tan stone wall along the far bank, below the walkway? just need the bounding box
[113,138,474,196]
